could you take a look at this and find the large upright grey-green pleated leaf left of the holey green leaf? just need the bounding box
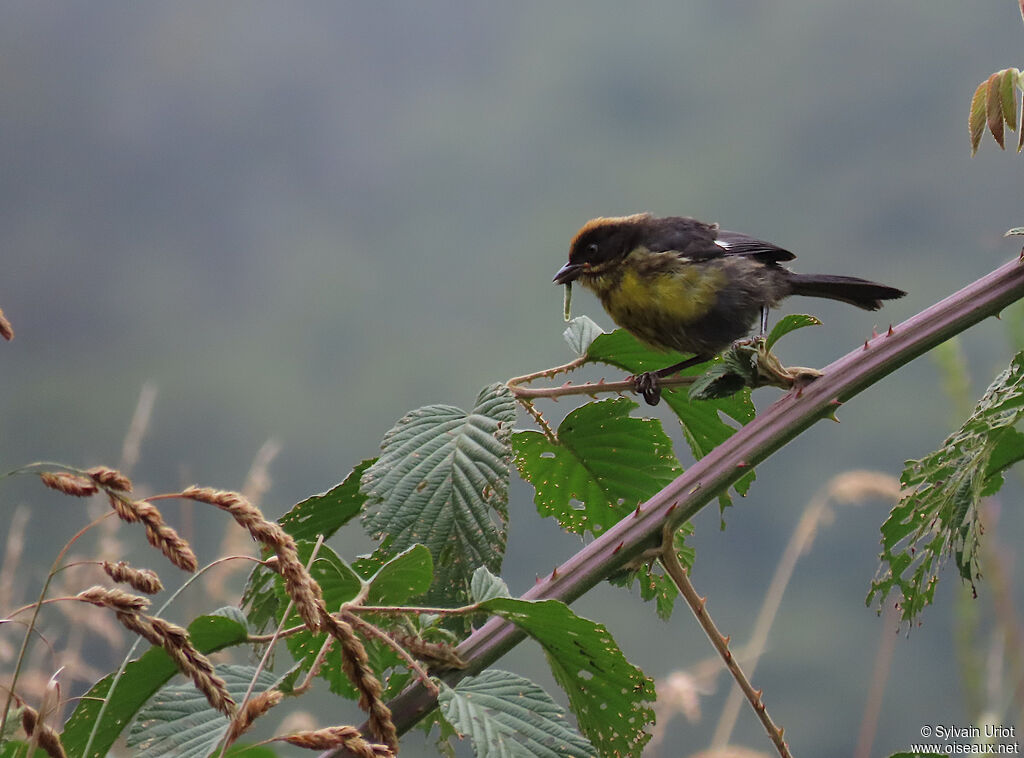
[361,384,515,601]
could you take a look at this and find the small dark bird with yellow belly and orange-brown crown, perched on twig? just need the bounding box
[554,213,906,406]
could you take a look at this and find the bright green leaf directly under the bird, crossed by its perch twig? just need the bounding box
[587,329,754,508]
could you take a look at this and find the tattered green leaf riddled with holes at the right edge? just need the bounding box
[867,352,1024,622]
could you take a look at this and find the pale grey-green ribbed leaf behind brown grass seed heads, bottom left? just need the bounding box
[126,666,278,758]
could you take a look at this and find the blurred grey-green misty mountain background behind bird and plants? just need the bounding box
[0,0,1024,756]
